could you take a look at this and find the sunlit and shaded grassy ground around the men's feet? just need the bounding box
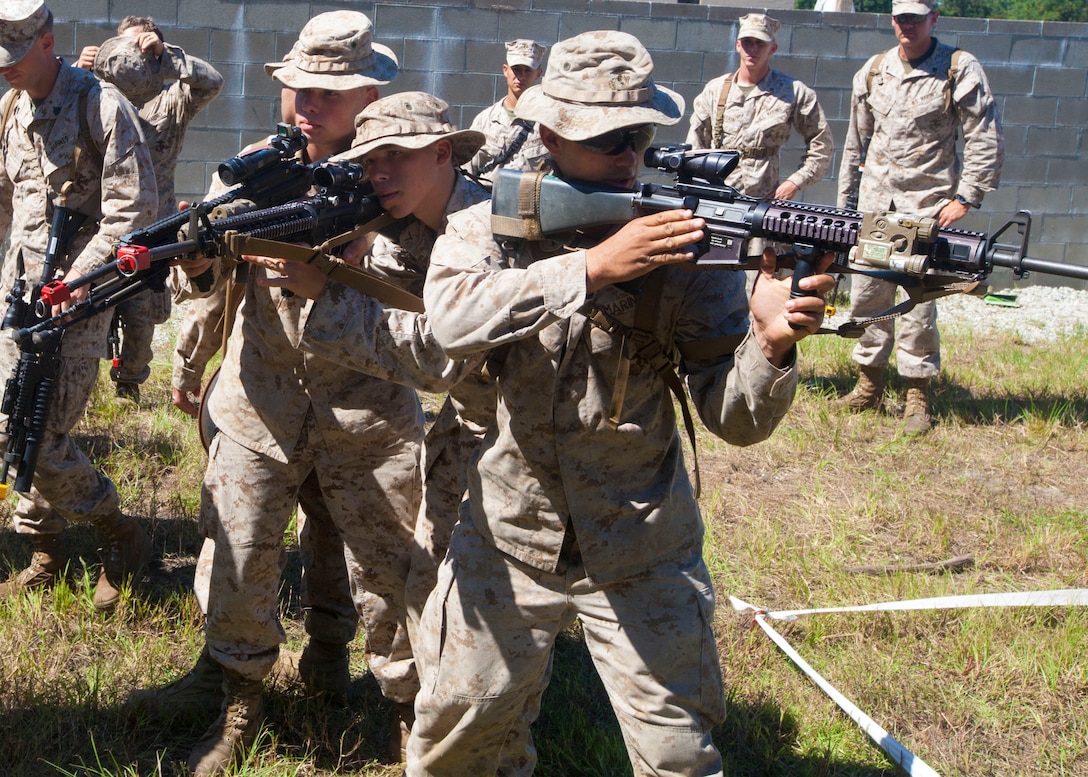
[0,304,1088,777]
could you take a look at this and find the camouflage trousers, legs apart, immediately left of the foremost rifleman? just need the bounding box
[201,424,420,702]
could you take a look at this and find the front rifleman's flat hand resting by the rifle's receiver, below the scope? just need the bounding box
[585,210,706,293]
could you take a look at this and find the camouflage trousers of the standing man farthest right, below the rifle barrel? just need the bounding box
[850,275,941,378]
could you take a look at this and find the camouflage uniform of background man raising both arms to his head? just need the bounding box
[95,36,223,383]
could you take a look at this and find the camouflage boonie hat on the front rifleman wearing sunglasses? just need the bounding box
[514,30,684,140]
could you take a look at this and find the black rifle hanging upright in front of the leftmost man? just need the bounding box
[0,200,87,500]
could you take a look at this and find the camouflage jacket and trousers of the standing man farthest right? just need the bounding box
[838,39,1004,378]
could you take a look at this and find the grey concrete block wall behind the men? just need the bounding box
[40,0,1088,287]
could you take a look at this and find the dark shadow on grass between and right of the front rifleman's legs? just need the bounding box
[533,633,899,777]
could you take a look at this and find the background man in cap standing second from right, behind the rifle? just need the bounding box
[687,13,832,200]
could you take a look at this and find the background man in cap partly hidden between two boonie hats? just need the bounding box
[465,38,547,181]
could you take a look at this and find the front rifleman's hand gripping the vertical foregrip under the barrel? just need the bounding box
[750,248,834,367]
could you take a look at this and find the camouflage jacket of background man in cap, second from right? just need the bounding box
[687,69,832,197]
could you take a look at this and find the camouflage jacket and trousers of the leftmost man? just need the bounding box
[0,63,158,534]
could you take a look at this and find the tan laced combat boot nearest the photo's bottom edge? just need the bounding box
[188,669,264,777]
